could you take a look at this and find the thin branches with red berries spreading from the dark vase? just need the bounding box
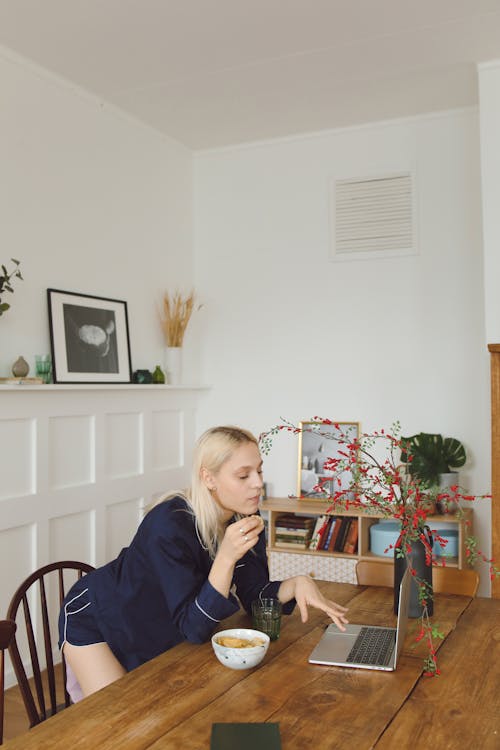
[260,417,494,675]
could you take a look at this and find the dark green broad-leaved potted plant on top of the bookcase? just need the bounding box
[401,432,467,513]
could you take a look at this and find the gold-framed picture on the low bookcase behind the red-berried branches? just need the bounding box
[297,422,360,500]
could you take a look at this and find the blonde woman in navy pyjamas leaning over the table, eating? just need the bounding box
[59,427,347,700]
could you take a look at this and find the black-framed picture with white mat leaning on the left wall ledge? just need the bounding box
[47,289,132,383]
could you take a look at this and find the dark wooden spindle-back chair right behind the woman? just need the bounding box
[7,560,94,727]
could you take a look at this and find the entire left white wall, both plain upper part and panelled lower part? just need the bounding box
[0,50,201,680]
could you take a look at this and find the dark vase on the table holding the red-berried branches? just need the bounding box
[394,526,434,617]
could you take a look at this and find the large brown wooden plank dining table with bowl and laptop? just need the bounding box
[5,582,500,750]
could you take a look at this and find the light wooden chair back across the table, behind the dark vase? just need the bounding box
[356,560,479,596]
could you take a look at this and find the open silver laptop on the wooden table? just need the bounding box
[309,569,411,672]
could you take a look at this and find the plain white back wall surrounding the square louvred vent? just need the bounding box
[195,110,490,589]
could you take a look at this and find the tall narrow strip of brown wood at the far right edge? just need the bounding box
[488,344,500,599]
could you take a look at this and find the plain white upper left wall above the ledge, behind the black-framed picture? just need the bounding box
[0,49,193,376]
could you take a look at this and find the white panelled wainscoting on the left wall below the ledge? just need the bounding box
[0,385,206,684]
